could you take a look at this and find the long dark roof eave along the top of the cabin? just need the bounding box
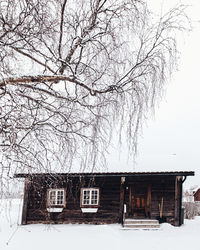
[14,171,195,178]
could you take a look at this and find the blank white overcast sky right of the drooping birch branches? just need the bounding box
[108,0,200,186]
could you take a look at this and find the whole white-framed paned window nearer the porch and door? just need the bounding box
[81,188,99,206]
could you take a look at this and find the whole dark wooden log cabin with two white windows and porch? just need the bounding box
[15,172,194,226]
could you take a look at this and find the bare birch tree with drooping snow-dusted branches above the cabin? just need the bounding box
[0,0,187,176]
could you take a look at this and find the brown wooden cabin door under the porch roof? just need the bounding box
[129,184,148,218]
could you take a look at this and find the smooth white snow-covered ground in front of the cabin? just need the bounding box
[0,200,200,250]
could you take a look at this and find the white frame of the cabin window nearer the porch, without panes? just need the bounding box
[80,187,100,208]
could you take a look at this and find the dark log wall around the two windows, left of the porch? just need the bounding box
[26,177,121,224]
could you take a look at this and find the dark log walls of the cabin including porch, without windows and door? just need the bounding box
[23,176,182,226]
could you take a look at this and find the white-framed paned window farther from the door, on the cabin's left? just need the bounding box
[48,189,65,206]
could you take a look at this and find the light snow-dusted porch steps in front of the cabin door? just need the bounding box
[123,219,160,229]
